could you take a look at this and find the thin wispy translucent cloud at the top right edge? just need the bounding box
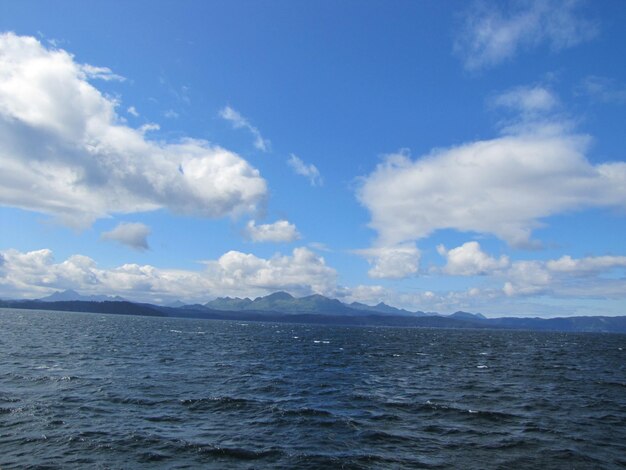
[455,0,598,70]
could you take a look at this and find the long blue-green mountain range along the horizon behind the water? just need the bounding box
[0,290,626,333]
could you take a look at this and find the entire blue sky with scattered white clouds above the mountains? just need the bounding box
[0,0,626,317]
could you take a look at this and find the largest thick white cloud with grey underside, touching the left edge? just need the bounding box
[0,33,267,227]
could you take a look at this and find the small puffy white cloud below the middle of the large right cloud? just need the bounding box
[437,241,510,276]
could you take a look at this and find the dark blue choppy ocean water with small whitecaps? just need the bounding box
[0,310,626,470]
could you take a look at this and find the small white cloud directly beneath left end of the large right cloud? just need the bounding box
[354,244,421,279]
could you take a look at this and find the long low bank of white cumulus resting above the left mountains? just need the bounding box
[0,248,337,302]
